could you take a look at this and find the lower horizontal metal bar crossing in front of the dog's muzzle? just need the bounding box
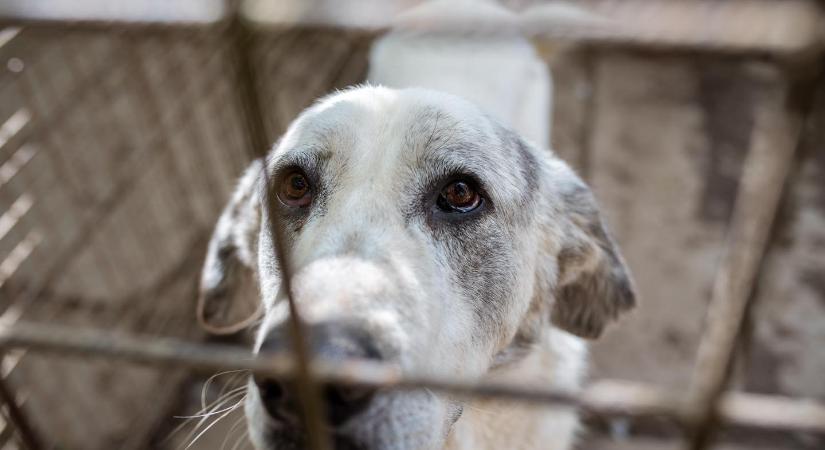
[0,322,825,433]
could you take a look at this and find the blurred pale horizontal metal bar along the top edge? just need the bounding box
[0,0,825,56]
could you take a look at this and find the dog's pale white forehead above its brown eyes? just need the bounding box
[275,87,535,199]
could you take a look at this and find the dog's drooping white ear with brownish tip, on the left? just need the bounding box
[197,159,263,334]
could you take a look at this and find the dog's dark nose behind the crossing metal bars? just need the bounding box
[255,323,382,426]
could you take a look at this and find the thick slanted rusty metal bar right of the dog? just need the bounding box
[684,64,803,450]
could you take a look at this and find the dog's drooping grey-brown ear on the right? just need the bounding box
[551,160,636,339]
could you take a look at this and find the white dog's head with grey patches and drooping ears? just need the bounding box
[196,87,634,450]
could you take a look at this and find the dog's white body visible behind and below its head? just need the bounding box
[368,0,586,450]
